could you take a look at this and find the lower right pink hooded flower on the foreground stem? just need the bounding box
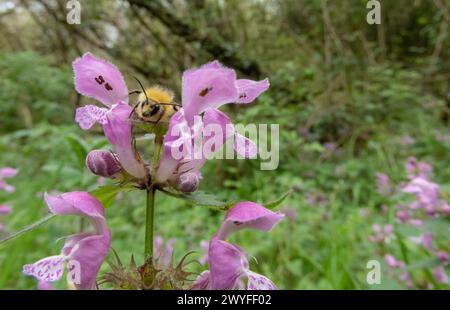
[193,202,284,290]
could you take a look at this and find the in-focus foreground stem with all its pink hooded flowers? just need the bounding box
[18,53,283,289]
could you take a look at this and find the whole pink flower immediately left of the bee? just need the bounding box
[72,53,147,179]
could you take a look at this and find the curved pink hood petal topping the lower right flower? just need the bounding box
[217,201,284,240]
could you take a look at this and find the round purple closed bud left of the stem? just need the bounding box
[86,150,122,178]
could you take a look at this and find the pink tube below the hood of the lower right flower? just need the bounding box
[208,237,248,290]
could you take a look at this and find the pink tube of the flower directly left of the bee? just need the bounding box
[103,102,146,179]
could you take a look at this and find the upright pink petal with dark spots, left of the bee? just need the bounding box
[72,53,128,107]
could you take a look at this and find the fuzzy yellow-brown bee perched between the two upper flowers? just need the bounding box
[130,80,180,124]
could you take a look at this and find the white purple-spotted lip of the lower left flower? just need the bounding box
[23,255,65,282]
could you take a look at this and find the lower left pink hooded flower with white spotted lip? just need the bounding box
[23,192,111,289]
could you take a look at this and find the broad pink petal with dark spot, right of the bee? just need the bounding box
[182,61,237,124]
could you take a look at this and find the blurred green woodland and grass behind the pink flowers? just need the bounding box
[0,0,450,289]
